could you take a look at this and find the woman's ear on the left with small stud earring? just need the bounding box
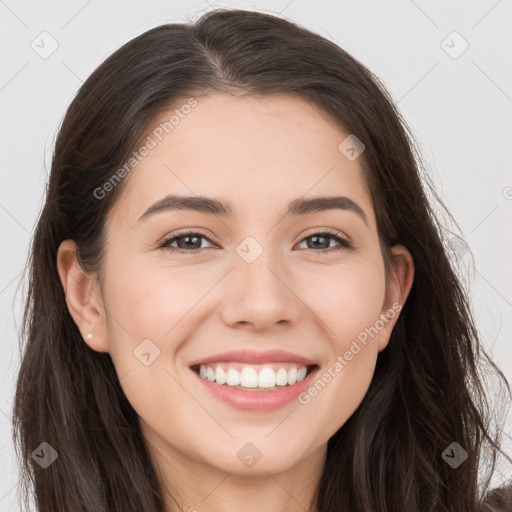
[57,240,109,352]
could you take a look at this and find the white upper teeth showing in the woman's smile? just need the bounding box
[199,364,307,388]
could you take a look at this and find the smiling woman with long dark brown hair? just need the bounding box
[14,10,510,512]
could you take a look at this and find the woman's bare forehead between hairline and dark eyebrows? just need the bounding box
[108,94,373,230]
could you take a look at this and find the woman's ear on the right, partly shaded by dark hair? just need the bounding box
[378,245,414,352]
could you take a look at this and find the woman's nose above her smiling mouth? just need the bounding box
[221,250,304,331]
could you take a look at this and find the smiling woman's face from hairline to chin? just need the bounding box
[58,95,412,480]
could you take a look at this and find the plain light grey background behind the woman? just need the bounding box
[0,0,512,512]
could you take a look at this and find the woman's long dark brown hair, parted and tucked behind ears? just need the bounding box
[14,9,510,512]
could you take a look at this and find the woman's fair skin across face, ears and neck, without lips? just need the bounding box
[58,94,414,512]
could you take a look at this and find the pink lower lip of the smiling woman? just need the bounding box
[191,367,318,412]
